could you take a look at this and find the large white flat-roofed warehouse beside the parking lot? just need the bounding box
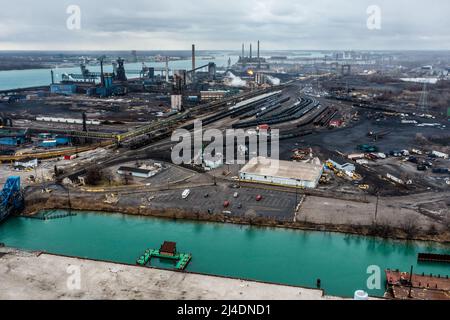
[239,157,323,189]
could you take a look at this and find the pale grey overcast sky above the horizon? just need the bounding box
[0,0,450,50]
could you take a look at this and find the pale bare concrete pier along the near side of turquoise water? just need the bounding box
[0,248,339,300]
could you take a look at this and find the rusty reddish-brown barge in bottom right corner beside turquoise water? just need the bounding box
[385,269,450,300]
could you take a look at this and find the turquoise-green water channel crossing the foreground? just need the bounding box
[0,212,450,297]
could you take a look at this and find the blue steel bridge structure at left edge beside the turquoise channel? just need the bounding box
[0,177,24,222]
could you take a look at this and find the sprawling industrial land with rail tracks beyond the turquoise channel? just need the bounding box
[0,49,450,300]
